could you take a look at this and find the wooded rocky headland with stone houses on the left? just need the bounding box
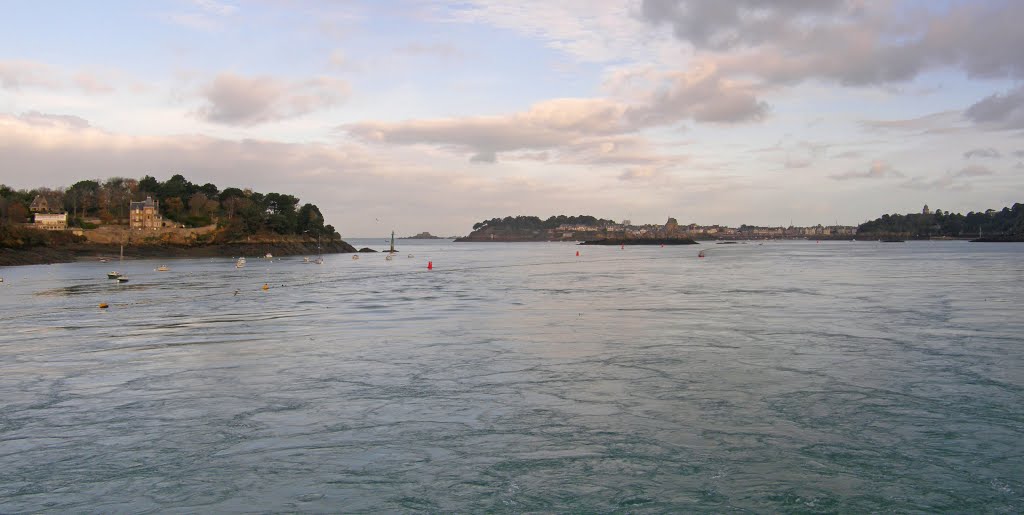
[0,175,355,266]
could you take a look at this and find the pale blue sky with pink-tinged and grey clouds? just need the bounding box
[0,0,1024,238]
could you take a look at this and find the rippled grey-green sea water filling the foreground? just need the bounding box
[0,240,1024,513]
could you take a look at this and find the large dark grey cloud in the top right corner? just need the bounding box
[641,0,1024,85]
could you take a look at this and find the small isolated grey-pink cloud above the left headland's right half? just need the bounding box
[197,73,349,126]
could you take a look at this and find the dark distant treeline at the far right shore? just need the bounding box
[857,203,1024,238]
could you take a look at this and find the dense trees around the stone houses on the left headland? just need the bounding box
[0,174,336,238]
